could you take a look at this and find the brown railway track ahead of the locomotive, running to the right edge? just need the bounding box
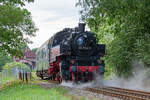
[85,87,150,100]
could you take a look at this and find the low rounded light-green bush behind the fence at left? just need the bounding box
[3,62,31,71]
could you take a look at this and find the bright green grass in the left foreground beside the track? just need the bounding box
[0,83,72,100]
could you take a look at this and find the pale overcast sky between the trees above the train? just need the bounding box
[26,0,79,48]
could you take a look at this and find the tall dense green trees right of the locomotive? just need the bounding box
[77,0,150,77]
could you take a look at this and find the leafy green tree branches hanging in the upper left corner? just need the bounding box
[0,0,37,57]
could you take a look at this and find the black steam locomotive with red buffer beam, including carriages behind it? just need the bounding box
[36,23,105,82]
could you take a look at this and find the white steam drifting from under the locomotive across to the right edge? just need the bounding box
[61,61,150,91]
